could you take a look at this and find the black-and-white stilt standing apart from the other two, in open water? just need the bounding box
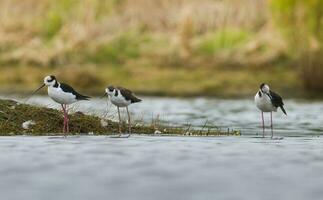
[255,83,287,138]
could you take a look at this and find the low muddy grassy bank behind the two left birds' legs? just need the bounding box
[0,100,240,136]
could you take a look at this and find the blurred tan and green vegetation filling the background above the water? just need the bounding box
[0,0,323,97]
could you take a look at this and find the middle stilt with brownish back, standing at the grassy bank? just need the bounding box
[105,86,142,137]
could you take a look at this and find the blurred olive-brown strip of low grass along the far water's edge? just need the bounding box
[0,65,323,99]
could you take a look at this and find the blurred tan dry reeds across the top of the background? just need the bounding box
[0,0,278,66]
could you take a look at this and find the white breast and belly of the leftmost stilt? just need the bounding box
[47,87,77,104]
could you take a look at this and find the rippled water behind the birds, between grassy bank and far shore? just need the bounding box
[6,96,323,136]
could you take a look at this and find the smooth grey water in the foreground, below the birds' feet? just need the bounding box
[0,136,323,200]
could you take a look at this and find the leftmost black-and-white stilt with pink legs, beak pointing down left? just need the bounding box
[33,75,90,137]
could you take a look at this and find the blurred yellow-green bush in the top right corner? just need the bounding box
[271,0,323,91]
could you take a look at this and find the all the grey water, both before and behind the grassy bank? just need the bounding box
[0,96,323,200]
